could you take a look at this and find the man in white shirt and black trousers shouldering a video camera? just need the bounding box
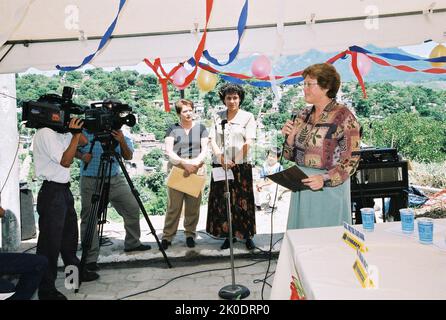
[33,118,99,300]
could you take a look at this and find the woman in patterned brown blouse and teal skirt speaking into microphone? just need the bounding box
[282,63,360,229]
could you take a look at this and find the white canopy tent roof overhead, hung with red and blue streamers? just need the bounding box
[0,0,446,73]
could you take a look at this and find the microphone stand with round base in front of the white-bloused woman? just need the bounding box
[218,119,250,300]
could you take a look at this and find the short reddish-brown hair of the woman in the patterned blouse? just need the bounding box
[302,63,341,99]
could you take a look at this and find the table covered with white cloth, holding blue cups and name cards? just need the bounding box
[271,219,446,299]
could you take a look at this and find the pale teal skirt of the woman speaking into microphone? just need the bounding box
[287,166,352,230]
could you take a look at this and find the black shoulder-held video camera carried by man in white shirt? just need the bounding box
[22,87,86,133]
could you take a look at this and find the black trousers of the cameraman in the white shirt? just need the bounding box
[37,181,79,290]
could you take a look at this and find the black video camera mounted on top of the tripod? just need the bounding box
[84,99,136,135]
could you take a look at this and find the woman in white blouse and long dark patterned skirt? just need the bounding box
[206,84,256,250]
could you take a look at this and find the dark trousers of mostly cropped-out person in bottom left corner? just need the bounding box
[0,252,48,300]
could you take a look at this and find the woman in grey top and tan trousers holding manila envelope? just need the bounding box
[161,99,208,250]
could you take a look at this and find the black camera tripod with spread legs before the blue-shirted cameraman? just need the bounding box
[79,134,172,285]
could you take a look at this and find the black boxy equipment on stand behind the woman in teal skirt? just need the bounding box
[350,148,409,224]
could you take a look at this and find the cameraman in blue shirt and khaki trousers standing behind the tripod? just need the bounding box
[76,99,151,271]
